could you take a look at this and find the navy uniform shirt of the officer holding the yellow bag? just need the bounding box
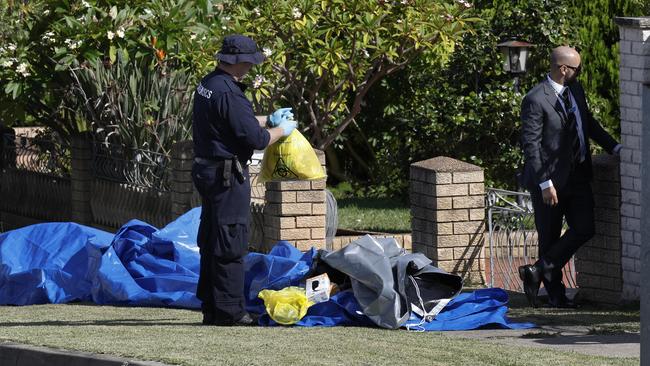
[192,69,271,162]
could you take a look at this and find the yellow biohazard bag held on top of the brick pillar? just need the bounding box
[260,130,327,182]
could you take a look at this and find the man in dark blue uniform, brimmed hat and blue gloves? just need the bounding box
[192,35,296,325]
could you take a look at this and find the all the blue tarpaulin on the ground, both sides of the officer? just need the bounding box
[0,208,534,330]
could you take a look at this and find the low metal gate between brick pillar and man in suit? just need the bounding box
[485,188,576,292]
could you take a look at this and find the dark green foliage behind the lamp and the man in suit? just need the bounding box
[346,0,649,195]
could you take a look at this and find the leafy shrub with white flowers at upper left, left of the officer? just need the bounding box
[0,0,224,142]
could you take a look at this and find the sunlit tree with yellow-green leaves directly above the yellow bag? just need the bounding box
[229,0,475,149]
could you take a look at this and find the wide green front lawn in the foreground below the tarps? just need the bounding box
[0,295,639,366]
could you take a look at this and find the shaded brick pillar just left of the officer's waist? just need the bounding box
[170,140,194,220]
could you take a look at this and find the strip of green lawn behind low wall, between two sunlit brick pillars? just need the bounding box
[336,197,411,233]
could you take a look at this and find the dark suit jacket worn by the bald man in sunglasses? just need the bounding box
[521,79,617,192]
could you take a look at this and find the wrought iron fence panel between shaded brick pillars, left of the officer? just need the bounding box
[93,142,170,192]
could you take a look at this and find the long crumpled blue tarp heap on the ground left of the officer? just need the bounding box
[0,209,201,308]
